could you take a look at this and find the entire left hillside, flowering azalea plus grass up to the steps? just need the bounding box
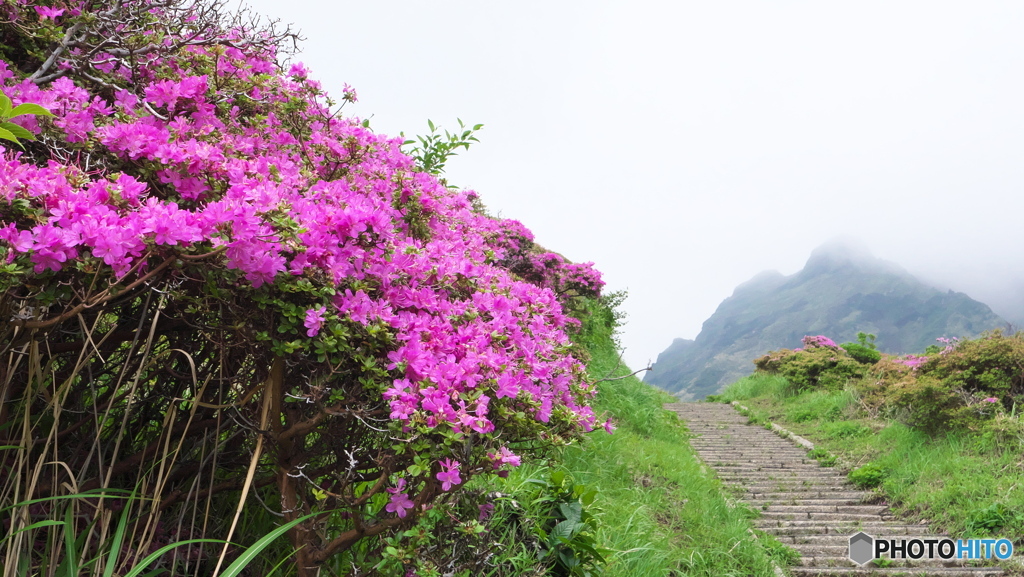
[0,0,790,577]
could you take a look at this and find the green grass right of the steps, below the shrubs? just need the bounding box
[719,375,1024,546]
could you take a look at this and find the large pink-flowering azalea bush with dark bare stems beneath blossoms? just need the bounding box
[0,0,603,575]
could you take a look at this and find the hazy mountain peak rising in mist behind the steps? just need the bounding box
[644,242,1007,400]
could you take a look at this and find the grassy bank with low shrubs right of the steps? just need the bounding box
[712,332,1024,546]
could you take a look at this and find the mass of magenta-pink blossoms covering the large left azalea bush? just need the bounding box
[0,0,608,565]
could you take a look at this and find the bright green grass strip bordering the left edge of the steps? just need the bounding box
[512,303,772,576]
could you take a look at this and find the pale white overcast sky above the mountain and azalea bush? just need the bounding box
[235,0,1024,368]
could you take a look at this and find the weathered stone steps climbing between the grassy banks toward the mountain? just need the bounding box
[666,403,1004,577]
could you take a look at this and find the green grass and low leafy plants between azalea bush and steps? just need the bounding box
[436,296,786,577]
